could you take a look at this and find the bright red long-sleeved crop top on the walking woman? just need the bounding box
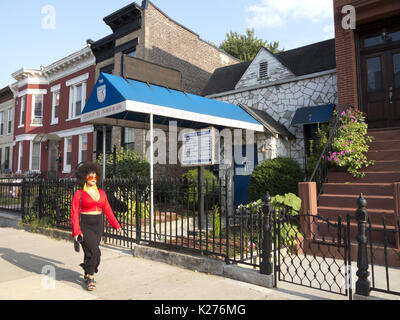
[71,189,121,237]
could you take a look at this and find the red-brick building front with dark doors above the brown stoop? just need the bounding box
[333,0,400,127]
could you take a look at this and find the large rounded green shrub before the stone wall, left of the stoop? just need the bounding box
[249,158,304,201]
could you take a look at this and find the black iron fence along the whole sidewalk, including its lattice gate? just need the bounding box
[0,177,400,298]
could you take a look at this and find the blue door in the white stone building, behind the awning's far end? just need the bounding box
[233,144,258,208]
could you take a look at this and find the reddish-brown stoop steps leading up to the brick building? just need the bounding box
[312,128,400,266]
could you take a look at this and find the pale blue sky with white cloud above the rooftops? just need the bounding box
[0,0,334,88]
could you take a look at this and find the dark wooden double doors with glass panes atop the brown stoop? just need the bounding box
[361,26,400,128]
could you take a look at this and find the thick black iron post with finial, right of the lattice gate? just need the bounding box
[356,194,371,296]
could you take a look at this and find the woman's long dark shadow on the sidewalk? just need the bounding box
[0,248,84,287]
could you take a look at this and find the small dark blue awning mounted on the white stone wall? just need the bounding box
[292,104,335,126]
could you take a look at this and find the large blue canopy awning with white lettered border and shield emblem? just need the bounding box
[81,73,264,132]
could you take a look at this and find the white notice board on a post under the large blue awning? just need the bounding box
[182,128,214,166]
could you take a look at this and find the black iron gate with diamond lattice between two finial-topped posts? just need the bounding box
[271,209,355,299]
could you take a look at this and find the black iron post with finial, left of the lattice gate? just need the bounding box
[260,193,272,275]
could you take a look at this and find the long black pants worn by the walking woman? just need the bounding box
[80,214,104,275]
